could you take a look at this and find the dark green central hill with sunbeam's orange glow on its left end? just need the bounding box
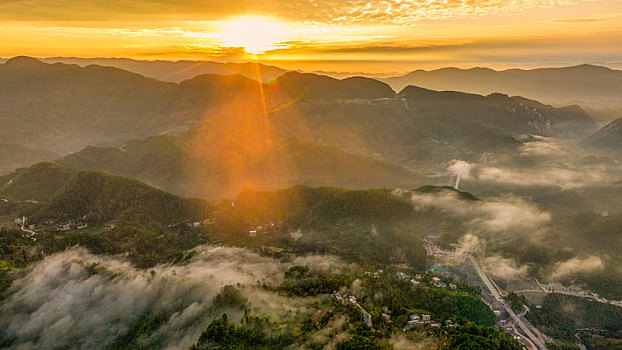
[215,186,425,267]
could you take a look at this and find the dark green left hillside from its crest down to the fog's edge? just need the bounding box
[0,163,214,270]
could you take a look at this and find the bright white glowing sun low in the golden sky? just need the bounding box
[218,16,287,54]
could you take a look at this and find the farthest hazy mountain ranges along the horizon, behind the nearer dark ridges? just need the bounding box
[11,57,622,115]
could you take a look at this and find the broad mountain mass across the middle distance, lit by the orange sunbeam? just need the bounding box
[0,57,597,197]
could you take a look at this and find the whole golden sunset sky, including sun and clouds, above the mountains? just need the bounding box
[0,0,622,73]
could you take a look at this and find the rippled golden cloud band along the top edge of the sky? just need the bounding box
[0,0,608,25]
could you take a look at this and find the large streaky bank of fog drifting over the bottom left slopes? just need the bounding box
[0,246,305,349]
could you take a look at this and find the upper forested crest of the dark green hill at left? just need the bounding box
[0,163,208,223]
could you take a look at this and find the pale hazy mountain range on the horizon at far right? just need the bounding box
[382,64,622,109]
